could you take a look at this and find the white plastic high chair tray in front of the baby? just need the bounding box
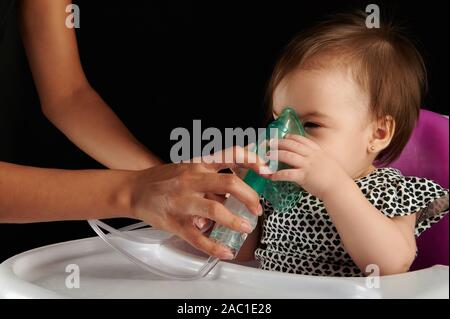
[0,237,449,299]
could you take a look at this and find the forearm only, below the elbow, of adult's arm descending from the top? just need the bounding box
[42,85,161,170]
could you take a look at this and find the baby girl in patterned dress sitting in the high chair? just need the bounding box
[238,13,448,276]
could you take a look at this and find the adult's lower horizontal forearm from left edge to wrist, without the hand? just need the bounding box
[0,162,134,223]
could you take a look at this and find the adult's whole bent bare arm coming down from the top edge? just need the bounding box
[19,0,159,170]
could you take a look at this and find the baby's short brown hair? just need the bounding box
[265,11,427,164]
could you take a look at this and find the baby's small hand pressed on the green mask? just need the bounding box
[268,134,349,200]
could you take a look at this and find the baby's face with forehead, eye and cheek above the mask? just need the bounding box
[273,68,373,178]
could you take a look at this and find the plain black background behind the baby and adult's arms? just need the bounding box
[0,0,449,261]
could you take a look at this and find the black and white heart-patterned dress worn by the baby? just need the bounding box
[255,168,449,276]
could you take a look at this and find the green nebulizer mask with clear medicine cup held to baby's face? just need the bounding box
[209,107,305,257]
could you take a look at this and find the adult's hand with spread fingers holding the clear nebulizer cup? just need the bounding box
[130,148,264,259]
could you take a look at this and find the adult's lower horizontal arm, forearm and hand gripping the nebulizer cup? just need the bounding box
[0,159,262,259]
